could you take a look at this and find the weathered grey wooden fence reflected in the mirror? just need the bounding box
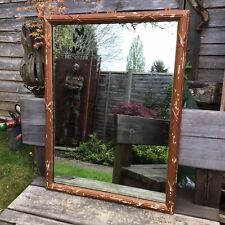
[94,72,172,137]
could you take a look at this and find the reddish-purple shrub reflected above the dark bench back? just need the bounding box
[112,102,158,118]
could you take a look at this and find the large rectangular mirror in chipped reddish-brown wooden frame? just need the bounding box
[45,11,187,212]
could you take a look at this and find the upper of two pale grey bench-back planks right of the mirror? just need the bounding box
[181,109,225,139]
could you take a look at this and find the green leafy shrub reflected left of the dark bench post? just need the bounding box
[66,134,114,166]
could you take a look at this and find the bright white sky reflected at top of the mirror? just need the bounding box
[97,22,177,72]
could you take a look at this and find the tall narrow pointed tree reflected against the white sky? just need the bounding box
[127,35,145,72]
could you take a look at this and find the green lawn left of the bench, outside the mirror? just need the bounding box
[0,132,36,212]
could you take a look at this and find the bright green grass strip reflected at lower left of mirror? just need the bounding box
[54,162,112,183]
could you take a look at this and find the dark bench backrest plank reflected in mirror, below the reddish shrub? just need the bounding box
[116,115,169,145]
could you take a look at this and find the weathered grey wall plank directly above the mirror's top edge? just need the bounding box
[65,0,179,14]
